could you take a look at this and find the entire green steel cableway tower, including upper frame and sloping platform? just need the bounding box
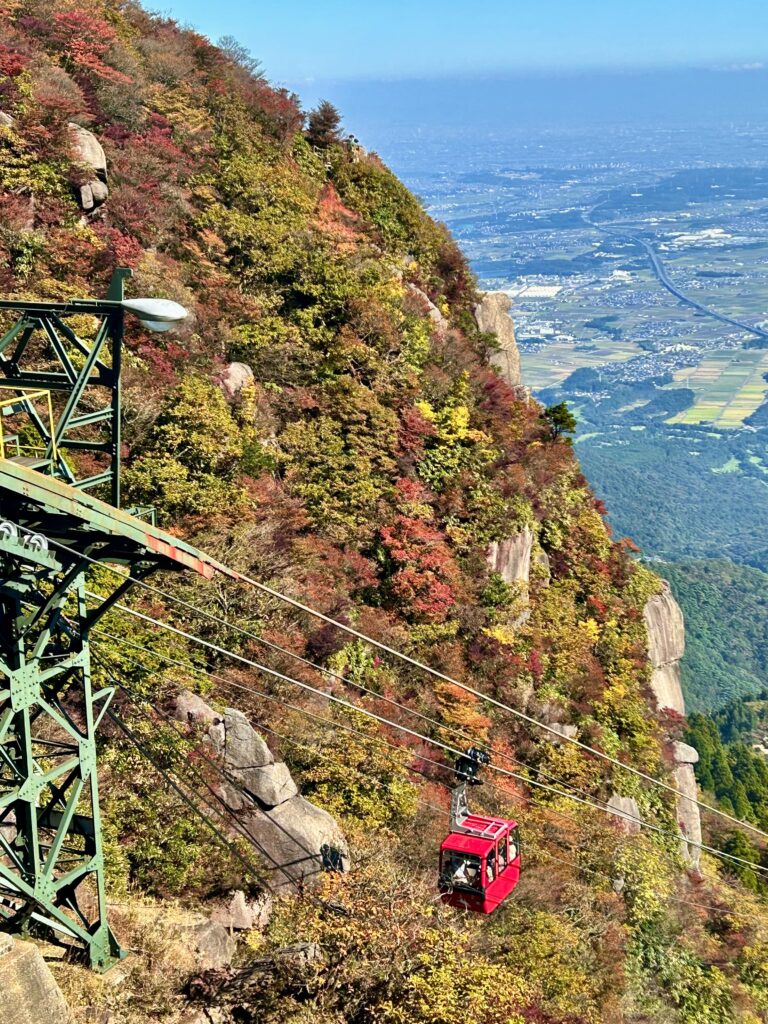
[0,271,231,971]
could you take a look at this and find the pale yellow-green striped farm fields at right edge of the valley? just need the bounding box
[667,349,768,429]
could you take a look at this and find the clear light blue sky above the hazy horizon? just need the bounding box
[157,0,768,86]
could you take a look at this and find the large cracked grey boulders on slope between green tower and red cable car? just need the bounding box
[175,692,349,889]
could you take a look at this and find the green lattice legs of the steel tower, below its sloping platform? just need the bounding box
[0,527,120,970]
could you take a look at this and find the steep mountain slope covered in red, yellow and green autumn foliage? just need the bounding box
[0,0,768,1024]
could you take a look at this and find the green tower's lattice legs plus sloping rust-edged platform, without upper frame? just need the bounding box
[0,460,237,970]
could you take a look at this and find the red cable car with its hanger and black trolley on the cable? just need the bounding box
[438,746,520,913]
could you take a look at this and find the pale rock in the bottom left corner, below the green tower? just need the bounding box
[0,935,72,1024]
